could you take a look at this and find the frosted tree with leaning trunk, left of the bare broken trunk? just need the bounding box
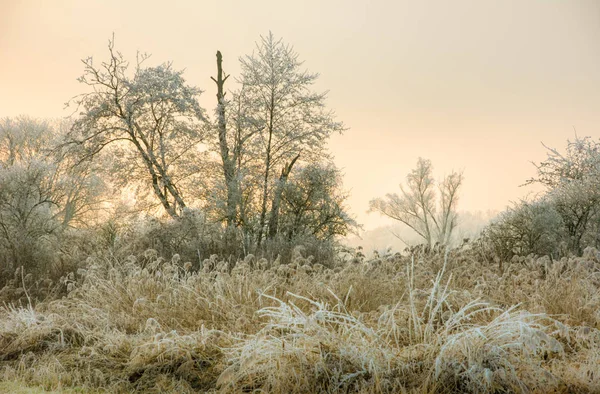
[69,40,205,218]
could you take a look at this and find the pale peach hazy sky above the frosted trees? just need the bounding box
[0,0,600,228]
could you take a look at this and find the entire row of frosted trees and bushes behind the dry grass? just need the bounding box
[0,33,600,284]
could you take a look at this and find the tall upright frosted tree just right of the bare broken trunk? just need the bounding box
[240,33,344,246]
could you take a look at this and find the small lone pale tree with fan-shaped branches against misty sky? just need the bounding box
[369,158,463,248]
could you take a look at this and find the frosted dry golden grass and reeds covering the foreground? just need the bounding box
[0,250,600,393]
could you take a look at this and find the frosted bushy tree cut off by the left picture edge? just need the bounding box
[0,117,102,270]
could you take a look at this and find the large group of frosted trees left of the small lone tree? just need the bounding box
[0,33,358,280]
